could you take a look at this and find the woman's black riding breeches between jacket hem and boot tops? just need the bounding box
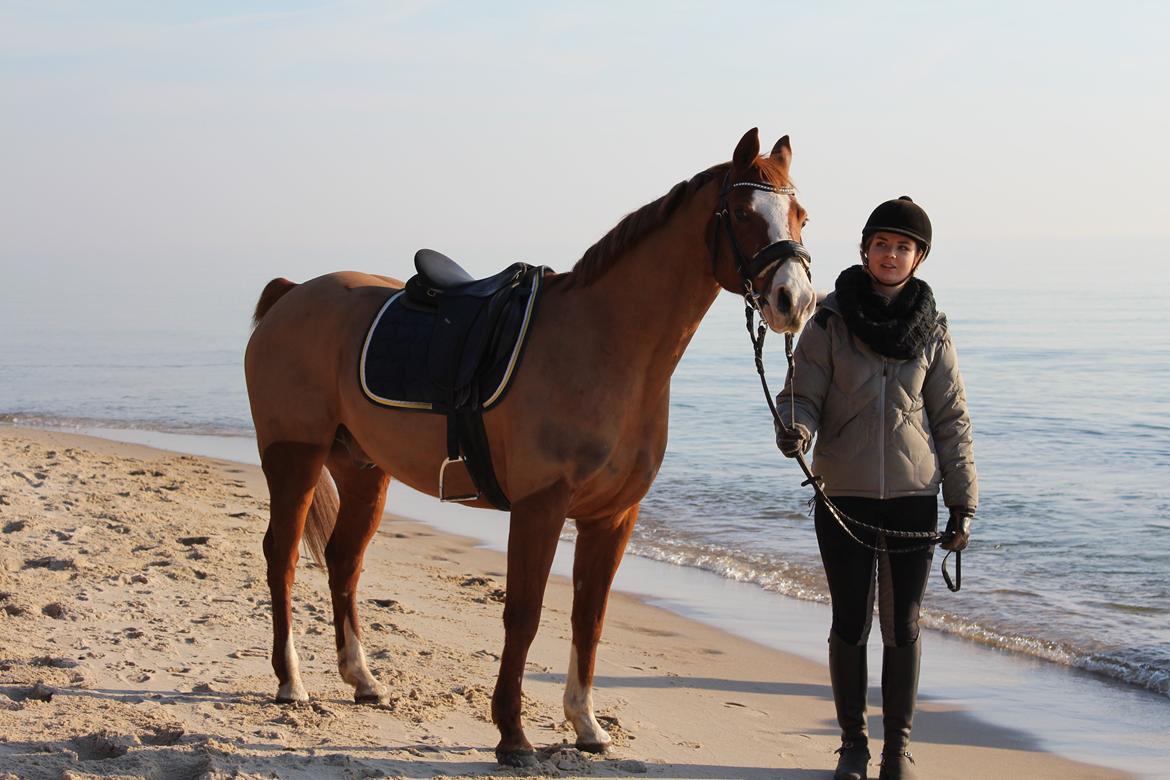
[815,496,938,647]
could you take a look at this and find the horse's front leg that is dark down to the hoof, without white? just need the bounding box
[491,482,569,766]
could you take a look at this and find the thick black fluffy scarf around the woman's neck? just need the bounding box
[837,265,938,360]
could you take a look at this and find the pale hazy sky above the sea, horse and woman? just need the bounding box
[0,0,1170,327]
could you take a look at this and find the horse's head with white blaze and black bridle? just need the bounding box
[713,127,817,333]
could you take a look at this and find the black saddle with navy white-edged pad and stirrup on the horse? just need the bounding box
[359,249,550,510]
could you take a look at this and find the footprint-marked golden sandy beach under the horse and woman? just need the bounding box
[0,428,1124,778]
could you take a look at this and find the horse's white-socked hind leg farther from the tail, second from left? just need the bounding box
[325,448,390,704]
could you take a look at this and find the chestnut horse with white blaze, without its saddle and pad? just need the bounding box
[245,129,815,766]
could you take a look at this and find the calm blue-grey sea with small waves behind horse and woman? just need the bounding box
[0,280,1170,776]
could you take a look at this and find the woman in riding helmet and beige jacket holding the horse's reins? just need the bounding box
[776,195,978,780]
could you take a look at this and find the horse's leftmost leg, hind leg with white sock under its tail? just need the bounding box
[260,442,328,702]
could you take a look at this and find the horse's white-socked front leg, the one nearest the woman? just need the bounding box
[565,504,638,753]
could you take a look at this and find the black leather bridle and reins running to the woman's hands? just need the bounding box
[711,172,963,593]
